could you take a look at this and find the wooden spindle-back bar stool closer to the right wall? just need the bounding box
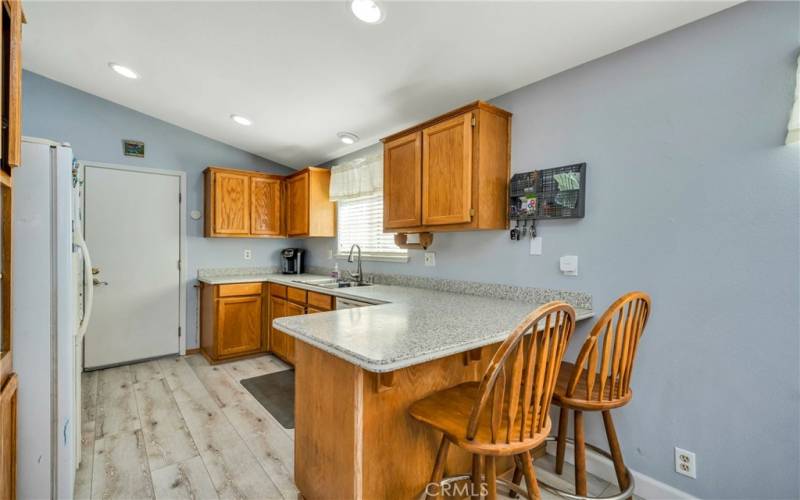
[513,292,650,497]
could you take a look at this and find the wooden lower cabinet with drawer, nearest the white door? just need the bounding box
[200,283,267,362]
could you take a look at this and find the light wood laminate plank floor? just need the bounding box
[75,354,617,500]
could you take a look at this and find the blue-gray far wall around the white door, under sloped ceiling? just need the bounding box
[22,71,302,348]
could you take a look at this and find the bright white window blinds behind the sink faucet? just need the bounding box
[337,195,408,262]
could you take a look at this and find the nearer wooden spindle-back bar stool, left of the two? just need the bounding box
[409,302,575,499]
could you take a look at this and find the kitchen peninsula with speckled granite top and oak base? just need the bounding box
[260,276,593,499]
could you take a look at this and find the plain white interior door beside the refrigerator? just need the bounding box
[84,165,180,369]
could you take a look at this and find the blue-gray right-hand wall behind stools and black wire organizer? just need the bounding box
[307,2,800,499]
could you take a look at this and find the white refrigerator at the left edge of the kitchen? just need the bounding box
[12,138,92,499]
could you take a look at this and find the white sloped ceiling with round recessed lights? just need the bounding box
[23,0,738,168]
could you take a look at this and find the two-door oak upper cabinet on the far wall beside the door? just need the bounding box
[203,167,284,238]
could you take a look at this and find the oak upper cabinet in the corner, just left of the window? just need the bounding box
[286,167,336,238]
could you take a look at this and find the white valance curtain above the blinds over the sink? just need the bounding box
[330,152,383,201]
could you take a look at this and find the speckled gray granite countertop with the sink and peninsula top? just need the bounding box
[200,273,594,373]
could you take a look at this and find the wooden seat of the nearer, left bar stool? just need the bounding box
[409,382,551,456]
